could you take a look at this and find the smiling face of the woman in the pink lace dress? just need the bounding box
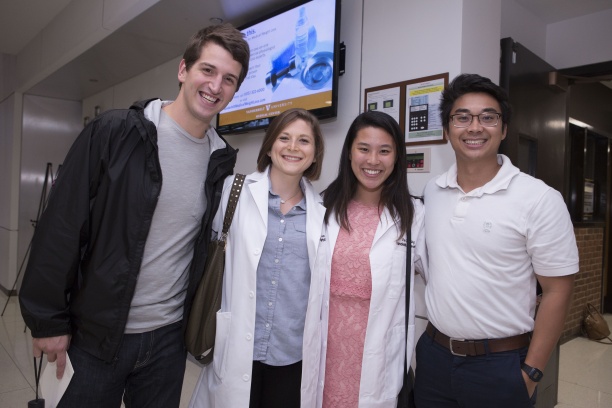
[350,126,397,204]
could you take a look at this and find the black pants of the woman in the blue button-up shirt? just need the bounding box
[249,361,302,408]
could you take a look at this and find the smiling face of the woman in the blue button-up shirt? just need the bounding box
[268,119,315,177]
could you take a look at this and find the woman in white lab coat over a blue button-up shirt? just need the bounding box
[190,109,329,408]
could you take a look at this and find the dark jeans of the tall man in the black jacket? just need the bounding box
[58,322,187,408]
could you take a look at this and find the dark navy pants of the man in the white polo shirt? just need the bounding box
[414,333,537,408]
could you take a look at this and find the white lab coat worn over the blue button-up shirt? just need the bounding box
[189,168,329,408]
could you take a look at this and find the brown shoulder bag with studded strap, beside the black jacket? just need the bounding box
[185,174,245,364]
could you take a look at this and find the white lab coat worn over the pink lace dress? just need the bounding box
[317,200,427,408]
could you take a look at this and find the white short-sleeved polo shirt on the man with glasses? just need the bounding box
[424,155,578,339]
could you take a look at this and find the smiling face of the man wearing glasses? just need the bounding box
[445,92,507,164]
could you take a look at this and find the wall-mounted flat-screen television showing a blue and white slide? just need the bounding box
[217,0,341,133]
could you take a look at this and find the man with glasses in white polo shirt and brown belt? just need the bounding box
[415,74,578,408]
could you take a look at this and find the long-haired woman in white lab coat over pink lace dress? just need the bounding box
[317,111,425,408]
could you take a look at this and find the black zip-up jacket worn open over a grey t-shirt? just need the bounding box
[19,100,237,362]
